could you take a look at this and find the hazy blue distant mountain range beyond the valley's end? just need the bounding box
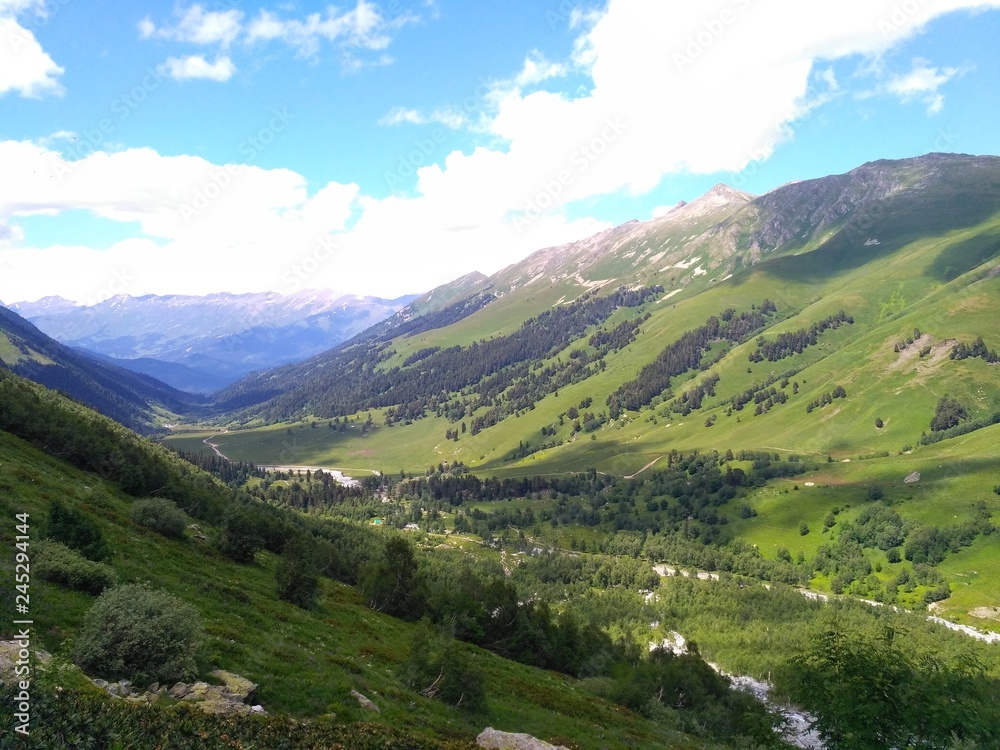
[10,290,415,392]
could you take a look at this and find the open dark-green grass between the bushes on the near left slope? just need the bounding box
[0,432,720,748]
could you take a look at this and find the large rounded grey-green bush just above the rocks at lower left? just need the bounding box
[75,584,205,685]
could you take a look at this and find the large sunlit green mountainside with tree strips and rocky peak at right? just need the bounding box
[158,154,1000,629]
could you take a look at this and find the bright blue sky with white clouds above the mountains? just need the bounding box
[0,0,1000,304]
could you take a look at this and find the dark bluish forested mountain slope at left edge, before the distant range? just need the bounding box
[0,307,203,432]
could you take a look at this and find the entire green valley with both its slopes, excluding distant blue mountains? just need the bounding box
[0,154,1000,749]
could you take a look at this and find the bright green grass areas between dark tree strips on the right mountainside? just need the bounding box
[164,192,1000,627]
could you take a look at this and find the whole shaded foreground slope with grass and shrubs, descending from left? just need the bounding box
[0,373,740,748]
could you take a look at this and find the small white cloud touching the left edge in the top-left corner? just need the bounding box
[0,11,65,98]
